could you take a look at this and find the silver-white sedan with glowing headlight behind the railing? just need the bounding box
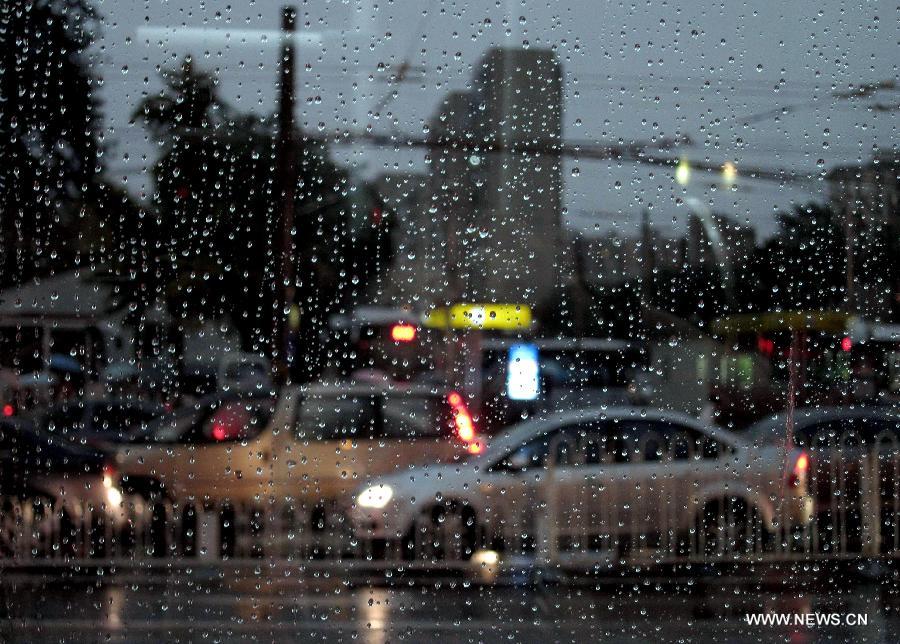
[349,407,811,559]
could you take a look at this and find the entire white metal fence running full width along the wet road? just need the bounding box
[0,437,900,570]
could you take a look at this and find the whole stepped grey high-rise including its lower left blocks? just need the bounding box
[377,49,566,308]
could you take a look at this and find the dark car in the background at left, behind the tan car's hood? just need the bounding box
[32,398,166,445]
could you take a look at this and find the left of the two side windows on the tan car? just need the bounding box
[295,395,381,440]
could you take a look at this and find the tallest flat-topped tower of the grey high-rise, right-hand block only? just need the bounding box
[469,49,566,305]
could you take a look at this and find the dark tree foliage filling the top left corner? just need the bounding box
[0,0,101,286]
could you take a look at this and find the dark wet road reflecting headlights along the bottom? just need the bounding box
[0,566,900,644]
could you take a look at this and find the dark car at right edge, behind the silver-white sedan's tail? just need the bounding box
[747,406,900,551]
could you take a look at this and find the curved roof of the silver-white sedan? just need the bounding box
[483,406,746,458]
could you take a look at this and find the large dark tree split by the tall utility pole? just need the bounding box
[134,58,388,370]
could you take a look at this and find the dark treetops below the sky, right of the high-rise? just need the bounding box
[538,203,856,337]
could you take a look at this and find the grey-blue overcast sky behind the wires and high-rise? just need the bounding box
[94,0,900,242]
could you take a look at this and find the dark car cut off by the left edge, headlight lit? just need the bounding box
[0,419,126,557]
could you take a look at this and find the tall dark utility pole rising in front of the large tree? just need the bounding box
[272,6,297,382]
